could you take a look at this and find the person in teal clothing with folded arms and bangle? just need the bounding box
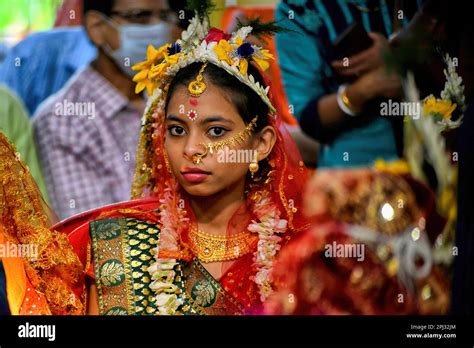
[276,0,418,167]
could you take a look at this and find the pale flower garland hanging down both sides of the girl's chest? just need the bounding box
[148,187,287,315]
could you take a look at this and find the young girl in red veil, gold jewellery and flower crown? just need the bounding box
[56,12,306,315]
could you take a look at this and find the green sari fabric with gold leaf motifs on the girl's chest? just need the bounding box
[90,217,243,315]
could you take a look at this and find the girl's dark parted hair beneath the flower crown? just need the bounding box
[165,63,269,131]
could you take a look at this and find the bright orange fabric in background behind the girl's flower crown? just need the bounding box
[221,6,298,126]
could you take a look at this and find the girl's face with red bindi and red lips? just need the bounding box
[165,83,261,197]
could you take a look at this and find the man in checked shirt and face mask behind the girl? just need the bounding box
[34,0,184,218]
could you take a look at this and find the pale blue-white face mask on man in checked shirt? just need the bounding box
[104,20,173,77]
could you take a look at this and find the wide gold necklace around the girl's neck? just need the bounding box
[189,229,257,263]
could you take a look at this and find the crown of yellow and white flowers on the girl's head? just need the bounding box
[132,15,275,113]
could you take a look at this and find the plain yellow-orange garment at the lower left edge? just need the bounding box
[0,226,26,315]
